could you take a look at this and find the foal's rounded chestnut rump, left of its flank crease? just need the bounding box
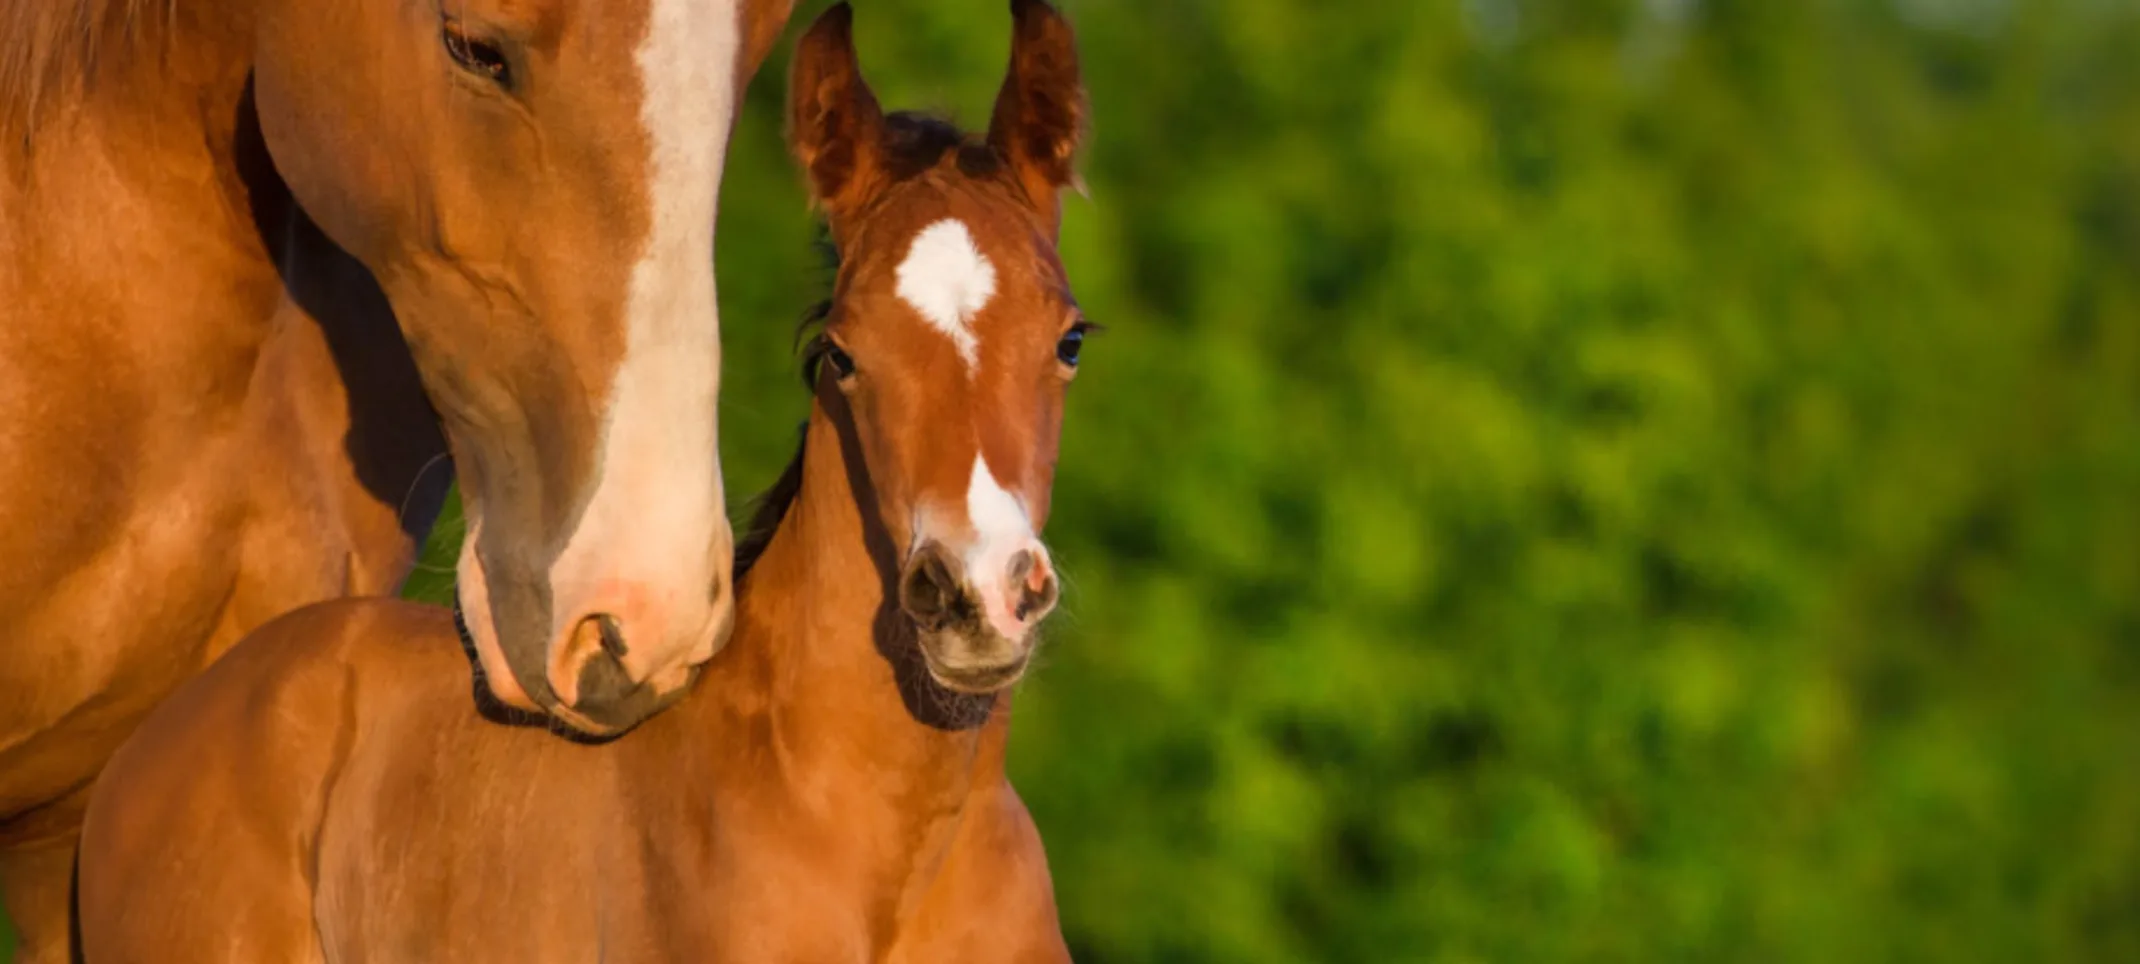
[77,600,469,934]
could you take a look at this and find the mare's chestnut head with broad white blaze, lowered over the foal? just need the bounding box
[253,0,792,735]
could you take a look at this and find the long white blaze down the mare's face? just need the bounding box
[530,0,738,673]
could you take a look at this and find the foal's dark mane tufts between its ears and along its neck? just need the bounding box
[734,111,1006,585]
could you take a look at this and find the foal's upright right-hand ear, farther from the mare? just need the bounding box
[989,0,1085,223]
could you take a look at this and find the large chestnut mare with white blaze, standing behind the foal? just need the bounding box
[0,0,792,962]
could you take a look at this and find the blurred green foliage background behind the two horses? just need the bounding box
[8,0,2140,962]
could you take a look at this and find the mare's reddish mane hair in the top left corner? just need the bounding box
[0,0,178,146]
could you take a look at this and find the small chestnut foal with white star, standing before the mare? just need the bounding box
[79,0,1085,964]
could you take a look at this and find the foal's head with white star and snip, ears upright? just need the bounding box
[790,0,1087,692]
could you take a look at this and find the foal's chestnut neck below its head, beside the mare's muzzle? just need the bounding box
[708,394,1008,818]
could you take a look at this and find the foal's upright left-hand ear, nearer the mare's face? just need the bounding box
[788,2,884,219]
